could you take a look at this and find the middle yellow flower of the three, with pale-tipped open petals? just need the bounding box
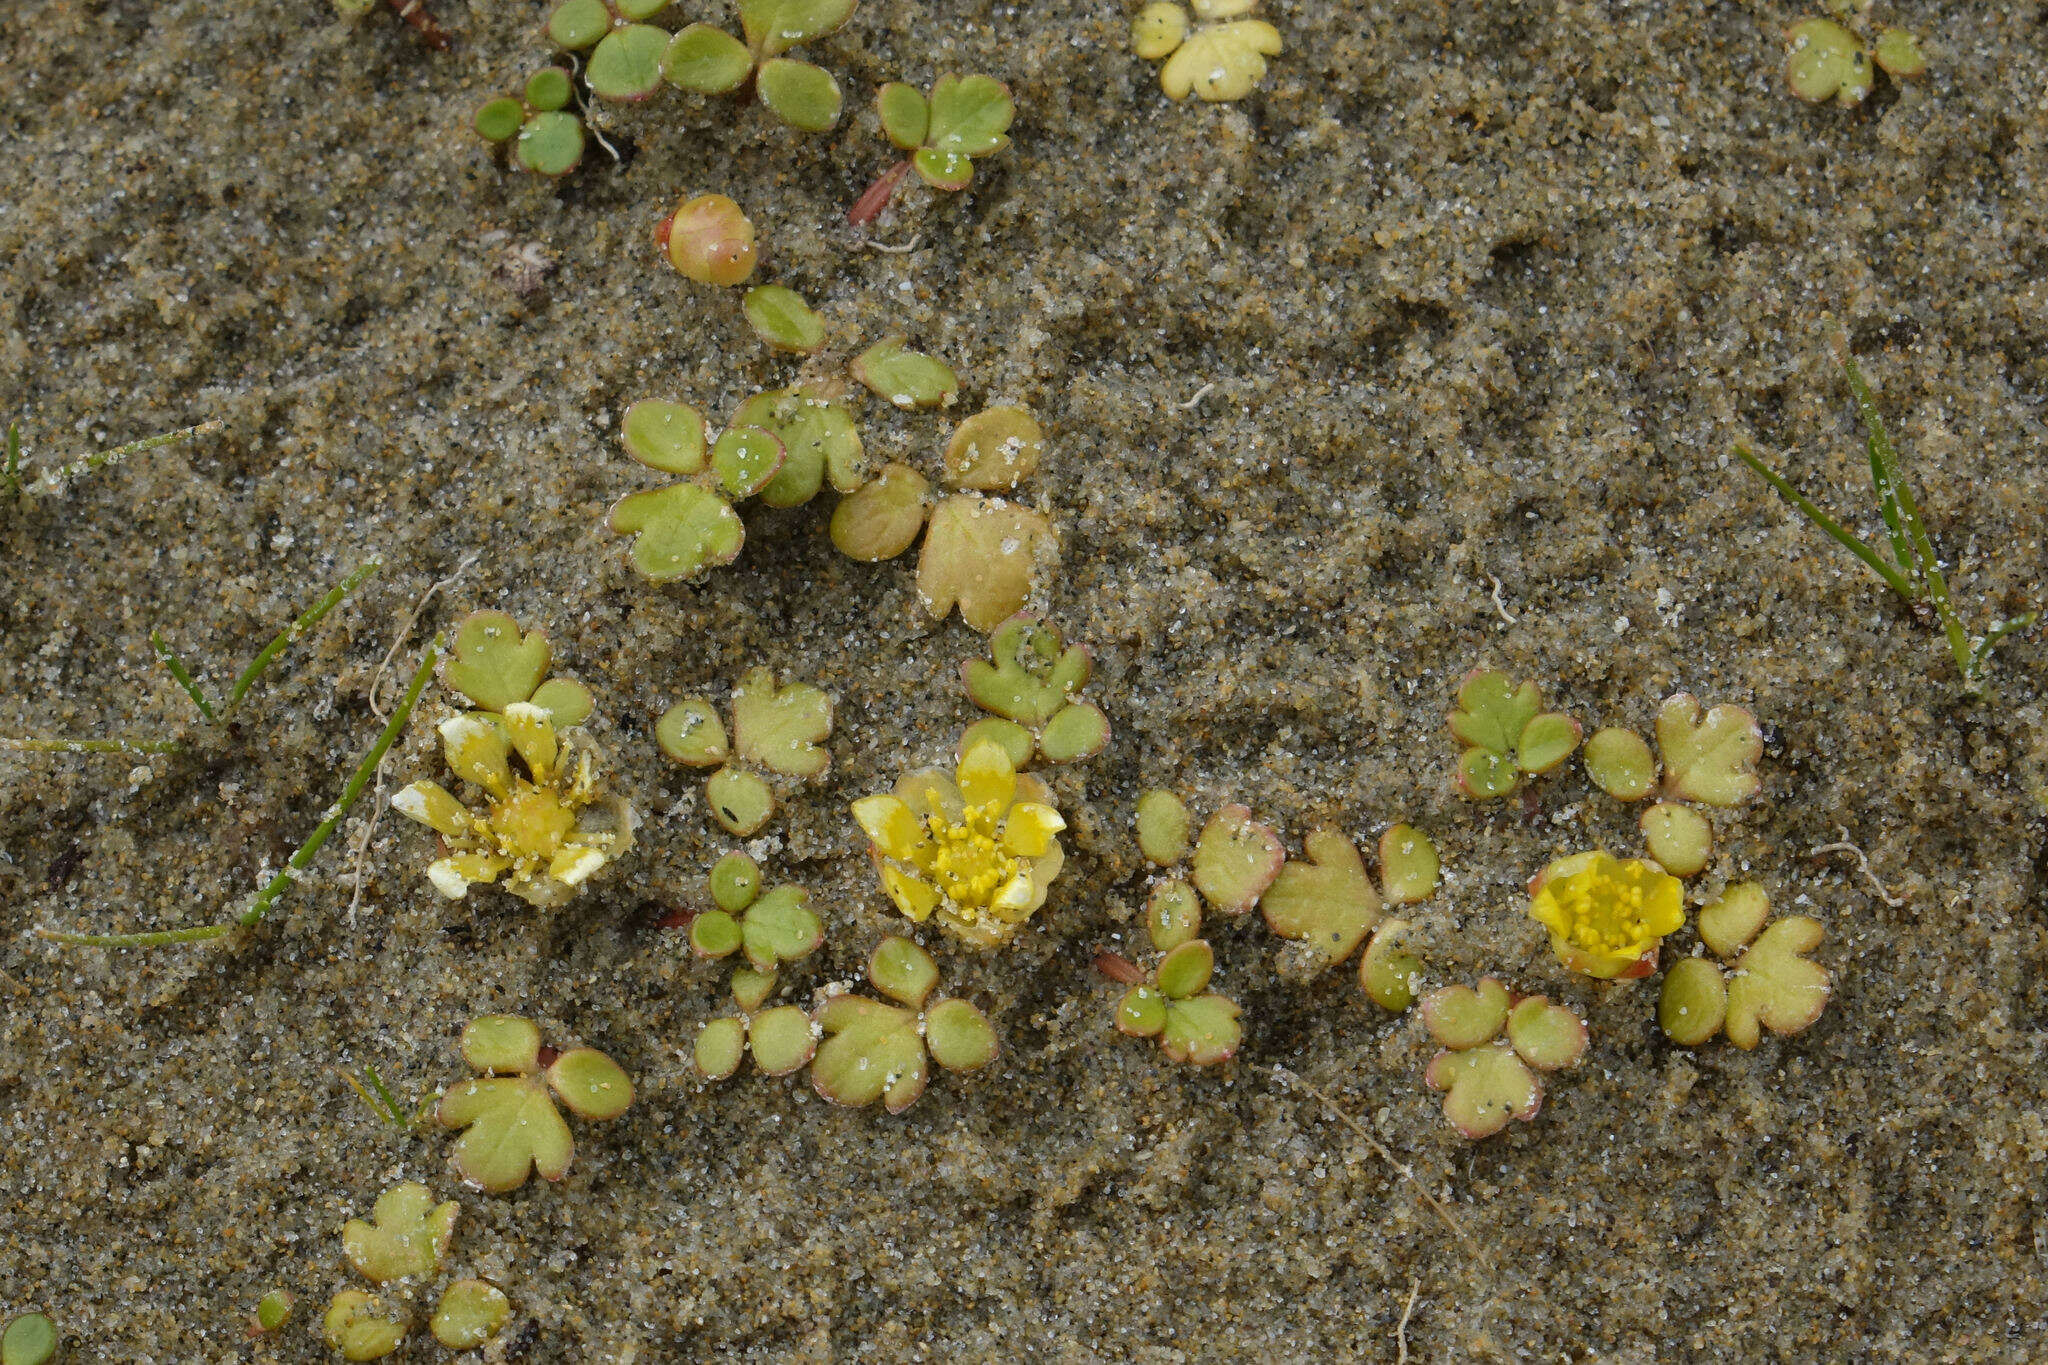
[854,741,1067,948]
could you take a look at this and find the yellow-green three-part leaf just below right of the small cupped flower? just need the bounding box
[1657,882,1833,1052]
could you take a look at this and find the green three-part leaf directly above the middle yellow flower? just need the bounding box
[961,614,1110,767]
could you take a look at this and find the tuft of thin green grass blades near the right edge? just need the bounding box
[1735,356,2040,696]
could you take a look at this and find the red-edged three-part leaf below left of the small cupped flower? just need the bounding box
[1421,976,1587,1140]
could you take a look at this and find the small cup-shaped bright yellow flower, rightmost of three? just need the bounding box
[1530,853,1686,980]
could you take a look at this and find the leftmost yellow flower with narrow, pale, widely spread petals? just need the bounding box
[391,702,633,907]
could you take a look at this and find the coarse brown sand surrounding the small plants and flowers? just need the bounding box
[0,0,2048,1361]
